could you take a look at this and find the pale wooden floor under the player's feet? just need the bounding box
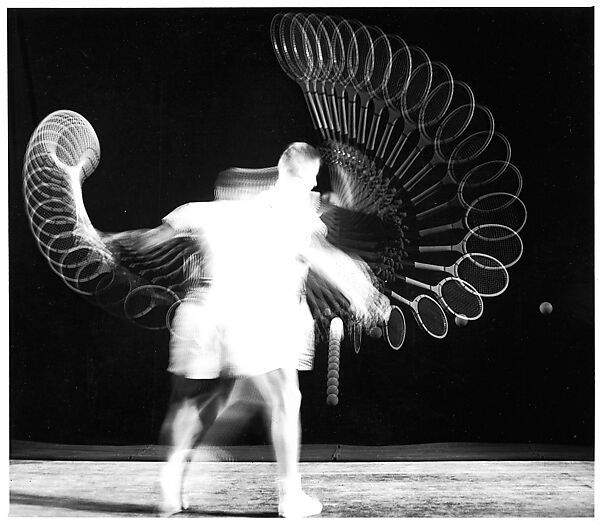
[9,456,594,518]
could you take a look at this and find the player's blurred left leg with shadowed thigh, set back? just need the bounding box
[160,375,232,515]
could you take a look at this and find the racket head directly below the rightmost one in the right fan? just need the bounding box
[460,224,523,269]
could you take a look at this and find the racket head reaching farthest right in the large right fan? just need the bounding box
[464,192,527,233]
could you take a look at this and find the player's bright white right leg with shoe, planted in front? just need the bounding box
[252,369,322,517]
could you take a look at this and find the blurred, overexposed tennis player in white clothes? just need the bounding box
[139,143,390,517]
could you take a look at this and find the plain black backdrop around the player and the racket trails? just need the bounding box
[8,8,594,444]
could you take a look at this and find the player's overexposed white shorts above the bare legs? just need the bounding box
[168,292,314,379]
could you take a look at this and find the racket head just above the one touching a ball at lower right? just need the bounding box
[454,253,509,297]
